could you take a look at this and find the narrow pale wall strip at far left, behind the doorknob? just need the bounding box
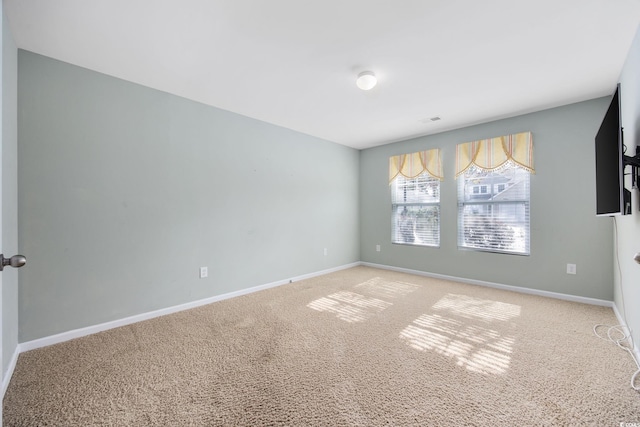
[0,9,19,378]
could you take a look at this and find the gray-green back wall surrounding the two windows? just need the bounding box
[360,97,615,301]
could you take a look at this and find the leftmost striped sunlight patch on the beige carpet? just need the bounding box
[307,291,393,323]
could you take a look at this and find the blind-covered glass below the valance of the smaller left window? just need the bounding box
[391,172,440,246]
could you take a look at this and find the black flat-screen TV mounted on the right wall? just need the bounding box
[596,85,630,216]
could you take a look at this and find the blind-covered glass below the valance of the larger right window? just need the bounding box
[458,162,530,255]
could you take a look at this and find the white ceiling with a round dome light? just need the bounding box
[4,0,640,149]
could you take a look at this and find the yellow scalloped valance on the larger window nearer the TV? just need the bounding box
[456,132,535,178]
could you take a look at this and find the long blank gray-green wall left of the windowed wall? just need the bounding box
[18,50,360,342]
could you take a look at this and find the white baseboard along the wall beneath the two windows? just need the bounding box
[360,262,614,307]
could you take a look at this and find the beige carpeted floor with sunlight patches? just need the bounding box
[4,267,640,426]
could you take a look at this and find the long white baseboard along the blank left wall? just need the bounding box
[17,262,360,356]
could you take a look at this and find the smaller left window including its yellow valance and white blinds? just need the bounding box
[389,148,442,247]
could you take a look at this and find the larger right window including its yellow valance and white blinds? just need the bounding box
[456,132,534,255]
